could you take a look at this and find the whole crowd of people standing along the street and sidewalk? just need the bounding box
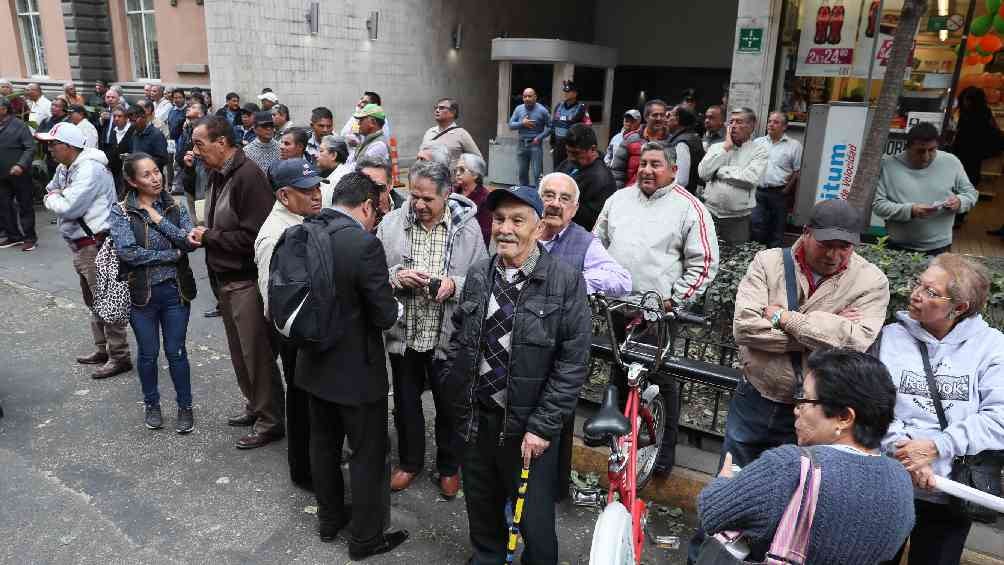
[0,76,1004,565]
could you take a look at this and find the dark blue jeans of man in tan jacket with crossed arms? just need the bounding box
[688,377,797,563]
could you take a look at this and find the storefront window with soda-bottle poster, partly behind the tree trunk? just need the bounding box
[771,0,971,132]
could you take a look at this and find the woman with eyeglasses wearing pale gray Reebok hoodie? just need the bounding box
[872,253,1004,565]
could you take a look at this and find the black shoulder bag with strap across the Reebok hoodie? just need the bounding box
[915,338,1004,524]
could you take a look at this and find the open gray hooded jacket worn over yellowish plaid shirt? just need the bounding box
[377,189,488,359]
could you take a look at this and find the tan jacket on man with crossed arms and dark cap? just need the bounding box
[732,239,889,403]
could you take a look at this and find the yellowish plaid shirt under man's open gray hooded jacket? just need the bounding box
[405,213,452,351]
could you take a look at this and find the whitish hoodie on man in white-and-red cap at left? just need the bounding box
[44,148,116,241]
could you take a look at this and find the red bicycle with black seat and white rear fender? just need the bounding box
[582,292,705,565]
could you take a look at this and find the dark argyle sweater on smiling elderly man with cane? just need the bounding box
[475,246,540,408]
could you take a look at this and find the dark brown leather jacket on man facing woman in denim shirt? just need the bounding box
[202,150,275,282]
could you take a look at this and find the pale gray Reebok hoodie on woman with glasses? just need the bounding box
[879,312,1004,503]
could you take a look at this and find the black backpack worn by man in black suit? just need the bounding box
[268,210,348,351]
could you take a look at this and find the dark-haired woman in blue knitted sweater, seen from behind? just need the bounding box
[698,349,914,565]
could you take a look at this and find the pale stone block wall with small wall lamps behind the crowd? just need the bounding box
[205,0,594,162]
